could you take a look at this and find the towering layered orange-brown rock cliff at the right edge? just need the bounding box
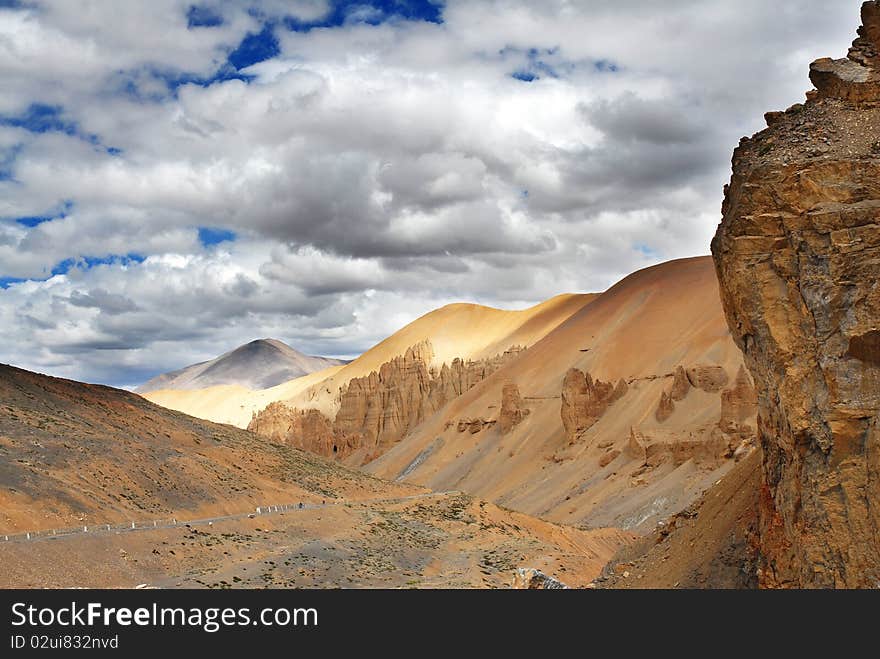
[712,1,880,587]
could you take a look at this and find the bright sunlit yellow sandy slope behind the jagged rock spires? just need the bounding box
[145,294,595,427]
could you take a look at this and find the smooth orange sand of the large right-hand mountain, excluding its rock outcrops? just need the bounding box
[367,257,742,530]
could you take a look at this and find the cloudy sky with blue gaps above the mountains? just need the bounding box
[0,0,860,387]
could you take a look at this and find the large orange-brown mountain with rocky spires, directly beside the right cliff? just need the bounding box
[365,257,755,532]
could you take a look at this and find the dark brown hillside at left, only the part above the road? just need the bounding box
[0,365,404,533]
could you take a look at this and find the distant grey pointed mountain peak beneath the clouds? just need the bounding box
[135,339,347,394]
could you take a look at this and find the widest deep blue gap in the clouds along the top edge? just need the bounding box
[284,0,443,32]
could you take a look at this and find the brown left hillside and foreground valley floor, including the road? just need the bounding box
[0,366,632,588]
